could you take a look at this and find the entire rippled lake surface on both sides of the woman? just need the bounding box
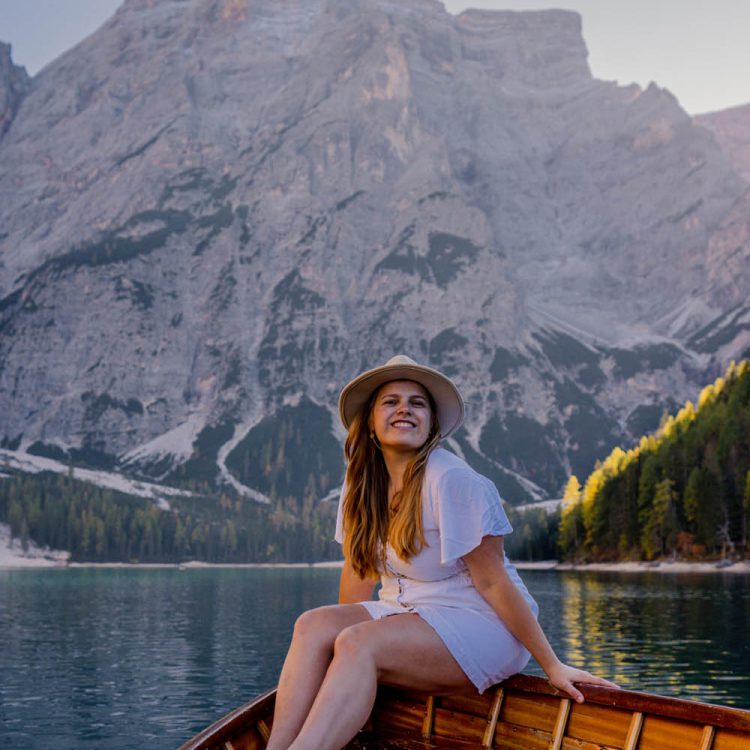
[0,568,750,750]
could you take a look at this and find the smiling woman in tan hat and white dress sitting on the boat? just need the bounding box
[268,355,613,750]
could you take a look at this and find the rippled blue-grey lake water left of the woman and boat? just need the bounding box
[0,569,337,750]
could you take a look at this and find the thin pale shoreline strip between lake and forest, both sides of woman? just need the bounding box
[0,557,750,575]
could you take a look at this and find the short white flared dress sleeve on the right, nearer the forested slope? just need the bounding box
[437,469,513,565]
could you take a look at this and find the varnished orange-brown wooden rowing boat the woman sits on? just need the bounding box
[180,675,750,750]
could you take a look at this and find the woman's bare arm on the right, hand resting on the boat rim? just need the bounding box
[463,536,617,703]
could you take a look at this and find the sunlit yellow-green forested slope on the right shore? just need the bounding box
[558,361,750,560]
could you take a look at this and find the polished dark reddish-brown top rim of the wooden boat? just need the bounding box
[179,674,750,750]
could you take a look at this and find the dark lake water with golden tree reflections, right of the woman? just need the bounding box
[525,572,750,707]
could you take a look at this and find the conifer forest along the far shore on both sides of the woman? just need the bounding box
[7,361,750,563]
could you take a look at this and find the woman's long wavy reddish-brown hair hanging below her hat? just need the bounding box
[343,388,440,579]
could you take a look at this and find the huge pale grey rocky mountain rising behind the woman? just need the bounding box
[0,0,750,503]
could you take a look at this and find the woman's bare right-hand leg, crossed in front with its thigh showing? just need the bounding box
[289,615,473,750]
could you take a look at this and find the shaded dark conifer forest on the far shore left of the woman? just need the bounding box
[0,473,340,563]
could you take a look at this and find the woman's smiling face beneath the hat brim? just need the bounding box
[370,380,432,453]
